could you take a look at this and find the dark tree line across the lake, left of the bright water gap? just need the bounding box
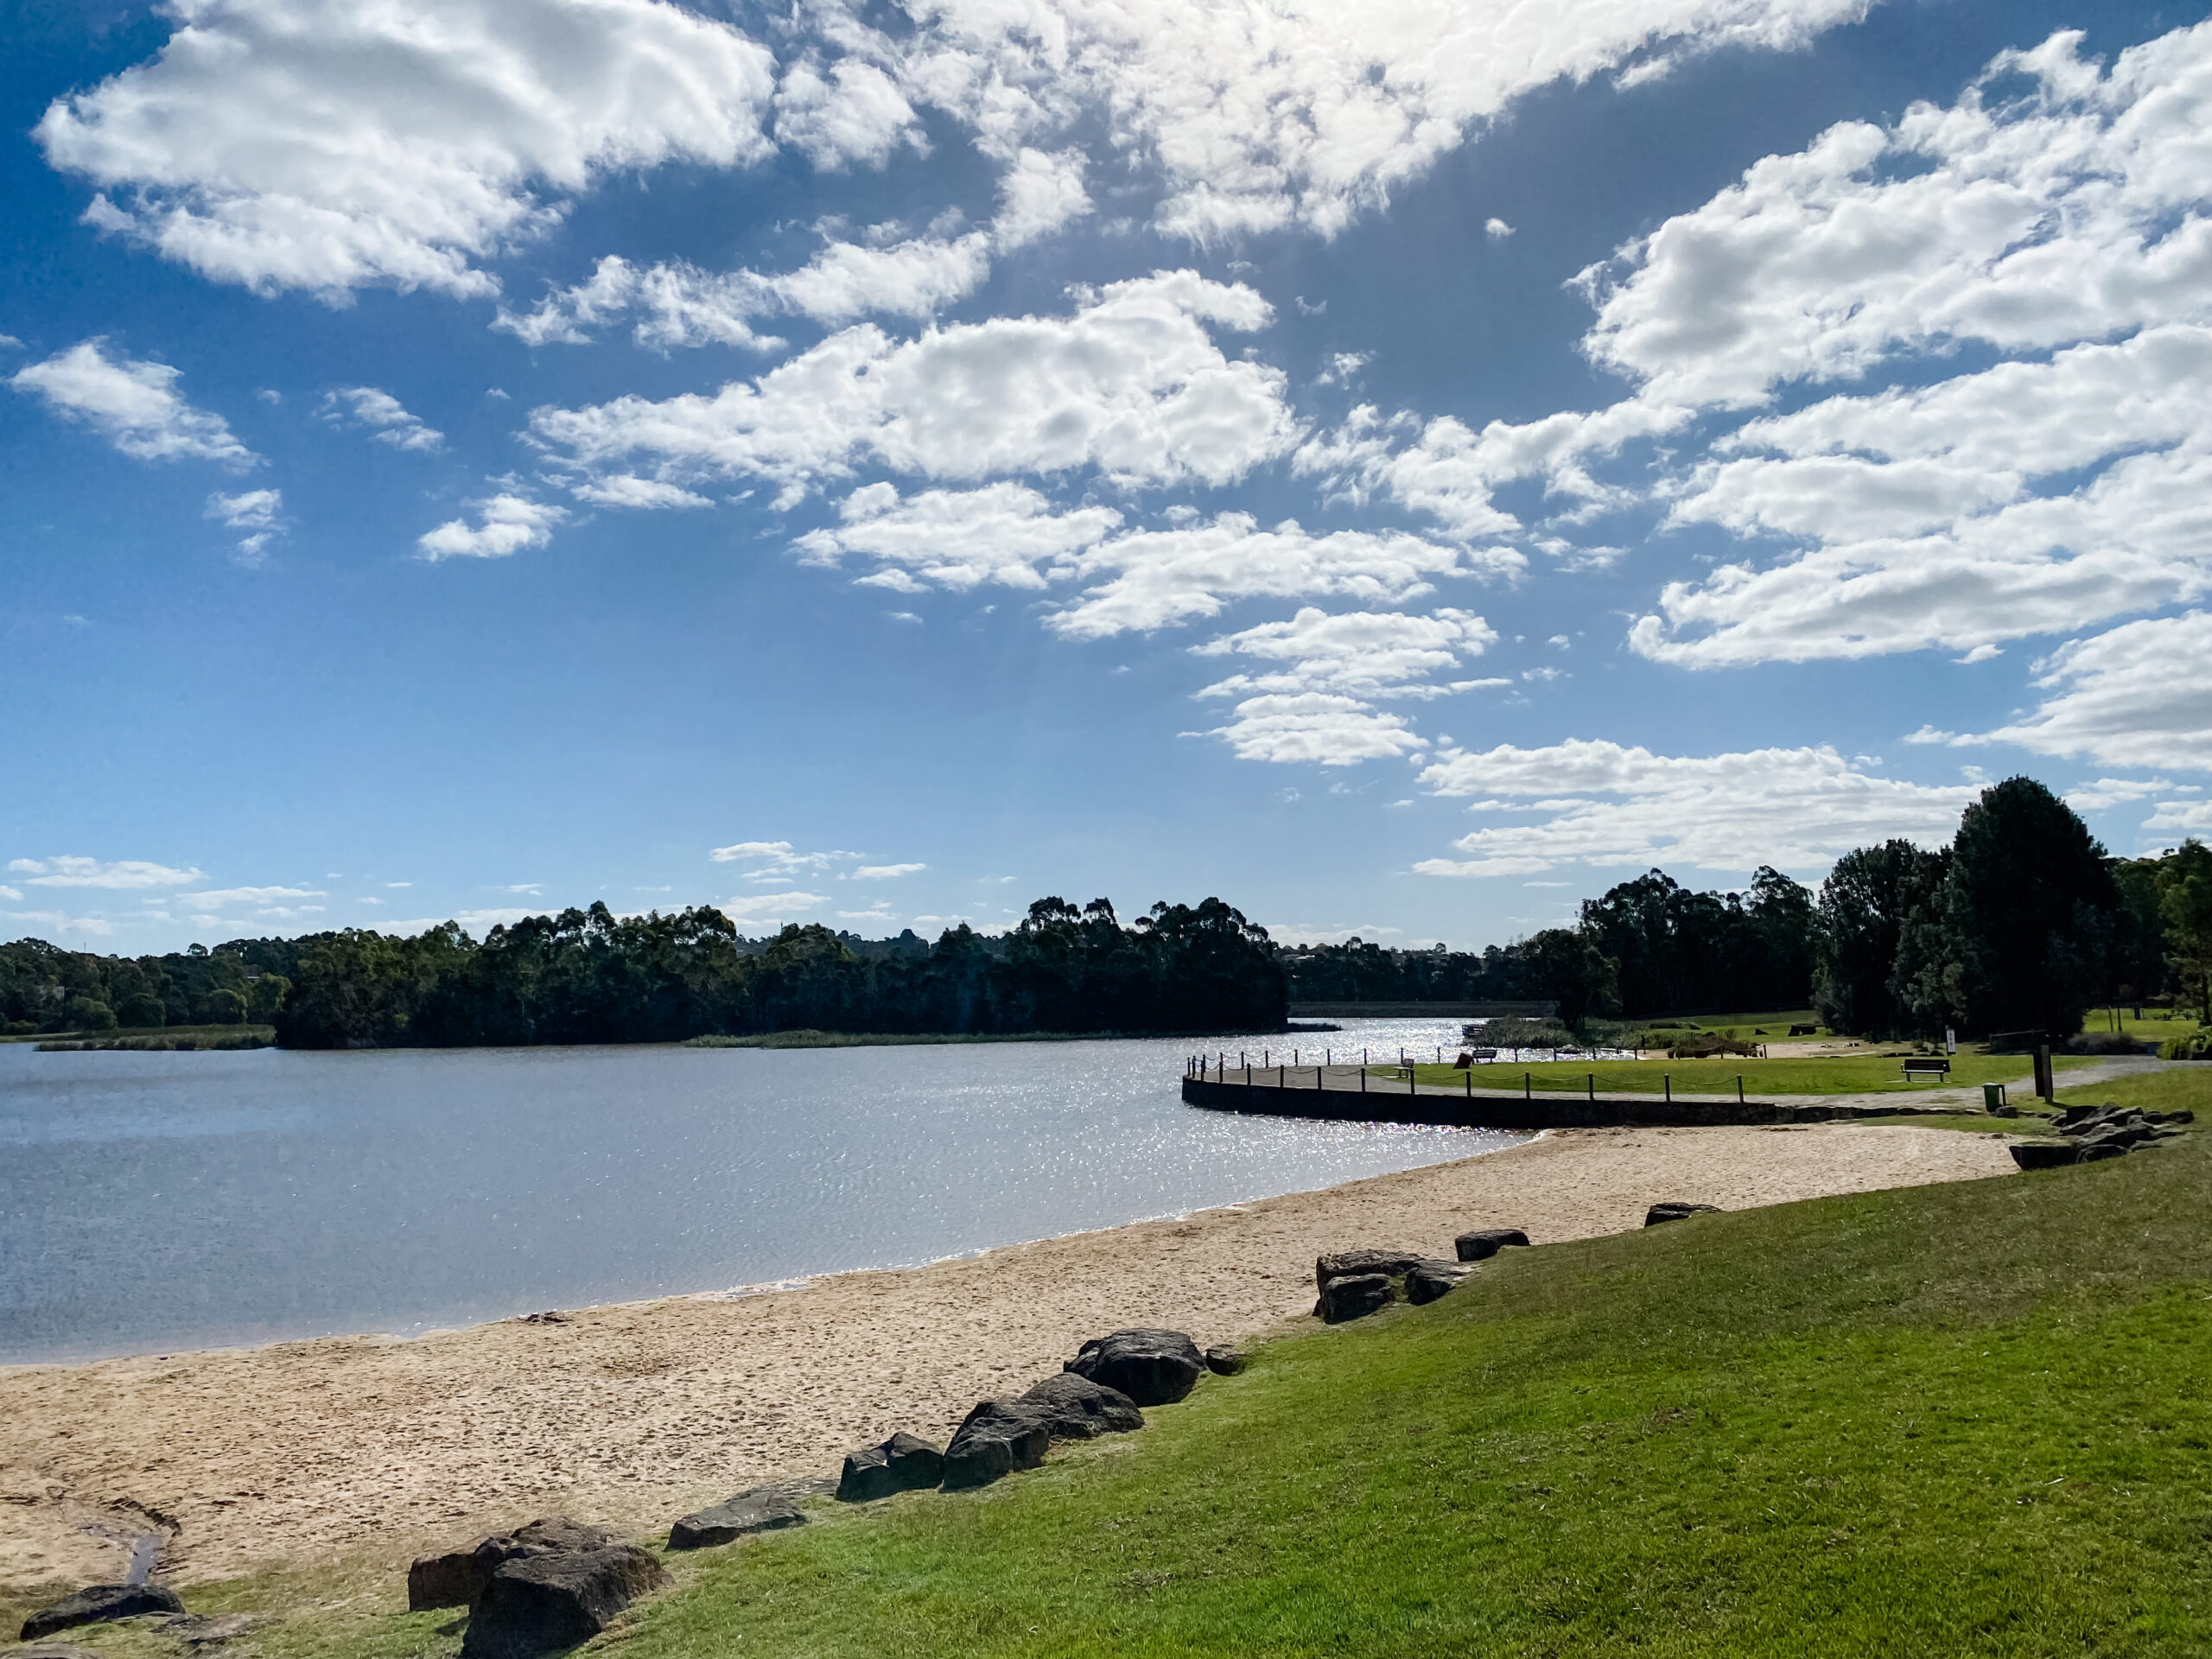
[0,898,1289,1048]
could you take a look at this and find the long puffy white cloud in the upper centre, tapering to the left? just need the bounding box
[531,272,1296,502]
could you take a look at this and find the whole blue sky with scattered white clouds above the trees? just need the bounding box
[0,0,2212,951]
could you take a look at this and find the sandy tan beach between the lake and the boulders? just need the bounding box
[0,1126,2013,1586]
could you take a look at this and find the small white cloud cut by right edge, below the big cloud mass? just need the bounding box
[1980,611,2212,772]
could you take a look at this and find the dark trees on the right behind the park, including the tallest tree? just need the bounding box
[1285,779,2212,1038]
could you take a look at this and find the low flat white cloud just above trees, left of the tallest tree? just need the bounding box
[1414,739,1978,876]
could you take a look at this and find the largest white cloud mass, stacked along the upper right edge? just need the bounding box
[1588,24,2212,666]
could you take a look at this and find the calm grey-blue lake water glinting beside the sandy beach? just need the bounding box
[0,1020,1524,1363]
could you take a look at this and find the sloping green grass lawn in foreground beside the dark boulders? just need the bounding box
[55,1066,2212,1659]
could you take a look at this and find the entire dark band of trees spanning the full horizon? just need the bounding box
[0,779,2212,1048]
